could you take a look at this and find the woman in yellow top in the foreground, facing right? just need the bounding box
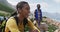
[5,1,40,32]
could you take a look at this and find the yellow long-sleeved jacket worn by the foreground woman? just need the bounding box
[5,17,40,32]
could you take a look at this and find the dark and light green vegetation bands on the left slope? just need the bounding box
[0,3,14,16]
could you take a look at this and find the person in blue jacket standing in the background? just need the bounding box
[34,4,42,27]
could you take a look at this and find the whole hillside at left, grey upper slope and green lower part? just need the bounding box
[0,0,15,16]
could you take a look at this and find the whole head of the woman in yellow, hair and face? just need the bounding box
[16,1,30,17]
